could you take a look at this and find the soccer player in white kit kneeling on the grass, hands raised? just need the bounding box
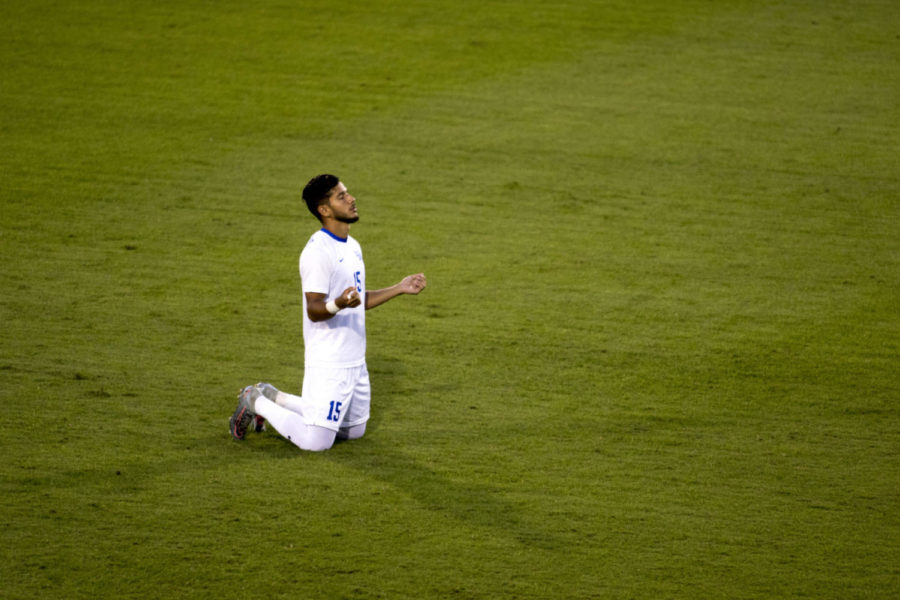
[230,174,426,451]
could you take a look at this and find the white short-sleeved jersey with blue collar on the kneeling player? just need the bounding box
[300,229,366,368]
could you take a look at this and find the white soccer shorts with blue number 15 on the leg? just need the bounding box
[301,364,372,431]
